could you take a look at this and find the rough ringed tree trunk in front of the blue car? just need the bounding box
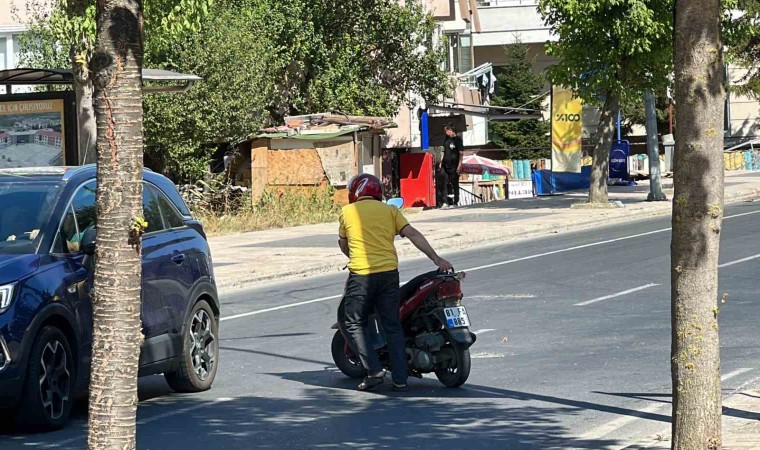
[88,0,143,450]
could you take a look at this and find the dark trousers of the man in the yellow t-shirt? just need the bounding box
[338,270,408,383]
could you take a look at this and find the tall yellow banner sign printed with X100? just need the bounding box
[552,86,583,173]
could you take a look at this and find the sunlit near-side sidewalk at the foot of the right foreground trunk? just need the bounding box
[625,390,760,450]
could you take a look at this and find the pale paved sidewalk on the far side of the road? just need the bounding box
[209,171,760,291]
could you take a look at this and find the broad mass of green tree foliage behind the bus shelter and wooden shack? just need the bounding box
[17,0,451,180]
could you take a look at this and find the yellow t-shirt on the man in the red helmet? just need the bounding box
[339,200,409,275]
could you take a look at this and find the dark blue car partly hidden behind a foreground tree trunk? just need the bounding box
[0,165,219,429]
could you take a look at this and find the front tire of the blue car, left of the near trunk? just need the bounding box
[16,326,76,431]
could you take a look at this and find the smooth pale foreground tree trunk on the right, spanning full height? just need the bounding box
[671,0,725,449]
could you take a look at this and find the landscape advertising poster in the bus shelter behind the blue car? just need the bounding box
[0,99,66,168]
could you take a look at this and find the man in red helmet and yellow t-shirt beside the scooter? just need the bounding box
[338,174,451,391]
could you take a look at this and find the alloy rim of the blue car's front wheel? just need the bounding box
[40,340,71,420]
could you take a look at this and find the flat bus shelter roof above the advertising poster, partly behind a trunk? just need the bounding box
[0,68,202,93]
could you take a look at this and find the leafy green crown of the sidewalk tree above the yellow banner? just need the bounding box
[539,0,673,104]
